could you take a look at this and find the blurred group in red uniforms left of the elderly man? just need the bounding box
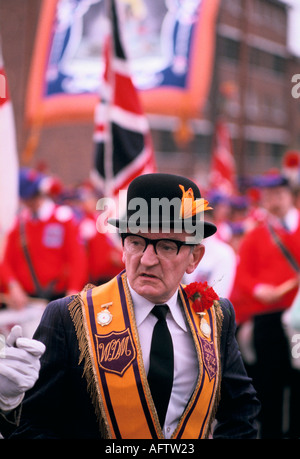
[0,168,123,309]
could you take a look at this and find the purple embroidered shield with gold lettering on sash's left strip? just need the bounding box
[95,328,136,376]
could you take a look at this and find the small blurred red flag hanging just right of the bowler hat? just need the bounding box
[209,120,237,195]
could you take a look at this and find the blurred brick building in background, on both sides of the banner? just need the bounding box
[0,0,300,187]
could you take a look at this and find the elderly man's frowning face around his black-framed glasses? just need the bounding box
[123,232,204,304]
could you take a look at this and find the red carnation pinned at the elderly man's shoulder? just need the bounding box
[184,281,219,314]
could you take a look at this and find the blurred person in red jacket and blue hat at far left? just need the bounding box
[1,168,88,310]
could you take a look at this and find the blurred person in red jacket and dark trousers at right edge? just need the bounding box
[231,173,300,439]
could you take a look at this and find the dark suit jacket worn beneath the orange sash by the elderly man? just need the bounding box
[10,297,260,439]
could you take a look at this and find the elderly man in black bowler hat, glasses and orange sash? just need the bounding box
[7,174,260,439]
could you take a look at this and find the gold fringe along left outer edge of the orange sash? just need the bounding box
[68,284,111,439]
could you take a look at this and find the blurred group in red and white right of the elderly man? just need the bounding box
[185,170,300,438]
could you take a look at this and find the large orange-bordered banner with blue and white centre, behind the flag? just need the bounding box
[26,0,220,125]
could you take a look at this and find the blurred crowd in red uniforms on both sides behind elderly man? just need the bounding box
[0,160,300,438]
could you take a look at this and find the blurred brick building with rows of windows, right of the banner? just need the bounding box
[155,0,300,180]
